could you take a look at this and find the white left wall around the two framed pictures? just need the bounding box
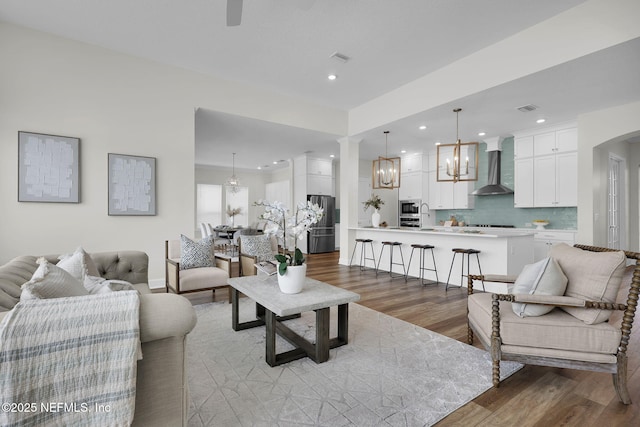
[0,23,347,279]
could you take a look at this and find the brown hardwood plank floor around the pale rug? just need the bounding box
[182,252,640,427]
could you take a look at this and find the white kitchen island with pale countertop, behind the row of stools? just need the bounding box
[349,227,534,292]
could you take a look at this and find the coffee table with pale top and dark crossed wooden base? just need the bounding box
[227,275,360,366]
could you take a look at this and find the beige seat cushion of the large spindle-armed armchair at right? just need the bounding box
[468,293,621,363]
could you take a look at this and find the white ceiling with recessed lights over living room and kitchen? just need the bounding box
[0,0,640,169]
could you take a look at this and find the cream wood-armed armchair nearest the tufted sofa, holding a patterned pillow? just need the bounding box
[165,236,231,302]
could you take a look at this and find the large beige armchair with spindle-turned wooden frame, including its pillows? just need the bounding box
[468,244,640,404]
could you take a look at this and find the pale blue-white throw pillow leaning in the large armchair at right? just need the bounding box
[511,258,568,317]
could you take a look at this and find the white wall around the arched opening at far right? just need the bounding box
[576,102,640,250]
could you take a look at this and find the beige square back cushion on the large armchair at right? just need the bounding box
[551,243,626,325]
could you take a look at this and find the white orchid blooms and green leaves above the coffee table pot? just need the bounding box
[254,200,324,275]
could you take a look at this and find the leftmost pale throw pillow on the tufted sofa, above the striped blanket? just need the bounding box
[20,258,89,300]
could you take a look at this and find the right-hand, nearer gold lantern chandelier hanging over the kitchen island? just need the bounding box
[436,108,479,183]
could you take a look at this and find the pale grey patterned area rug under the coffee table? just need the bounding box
[188,298,522,426]
